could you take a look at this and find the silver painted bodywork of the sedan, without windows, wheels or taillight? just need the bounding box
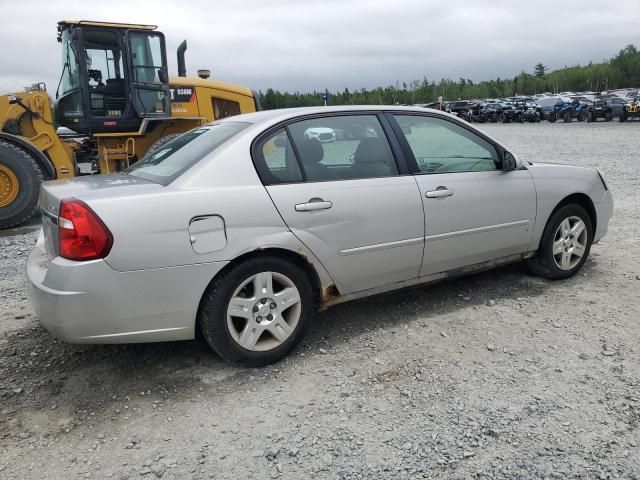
[27,107,613,343]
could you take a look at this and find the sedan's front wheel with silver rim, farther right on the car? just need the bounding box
[528,204,593,279]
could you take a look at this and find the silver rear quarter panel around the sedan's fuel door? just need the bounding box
[83,135,332,287]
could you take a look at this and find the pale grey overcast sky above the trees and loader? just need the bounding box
[0,0,640,93]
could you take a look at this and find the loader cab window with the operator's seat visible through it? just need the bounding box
[84,30,127,117]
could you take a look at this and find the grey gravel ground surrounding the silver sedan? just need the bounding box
[0,122,640,479]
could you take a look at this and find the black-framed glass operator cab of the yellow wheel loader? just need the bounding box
[55,21,171,135]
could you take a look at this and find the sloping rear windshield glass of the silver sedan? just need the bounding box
[127,122,249,185]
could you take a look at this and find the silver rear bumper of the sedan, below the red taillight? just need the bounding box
[26,232,226,343]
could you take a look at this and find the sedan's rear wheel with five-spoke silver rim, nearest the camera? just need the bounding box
[198,257,314,367]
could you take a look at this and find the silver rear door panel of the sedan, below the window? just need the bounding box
[267,176,424,293]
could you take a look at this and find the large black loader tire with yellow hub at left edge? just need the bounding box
[0,140,44,230]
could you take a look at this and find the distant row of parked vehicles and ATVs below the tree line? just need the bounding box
[420,89,640,123]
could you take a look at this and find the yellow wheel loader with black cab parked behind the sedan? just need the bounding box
[0,21,260,229]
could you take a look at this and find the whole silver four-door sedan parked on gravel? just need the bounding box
[27,106,613,366]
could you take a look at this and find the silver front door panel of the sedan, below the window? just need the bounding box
[416,169,536,276]
